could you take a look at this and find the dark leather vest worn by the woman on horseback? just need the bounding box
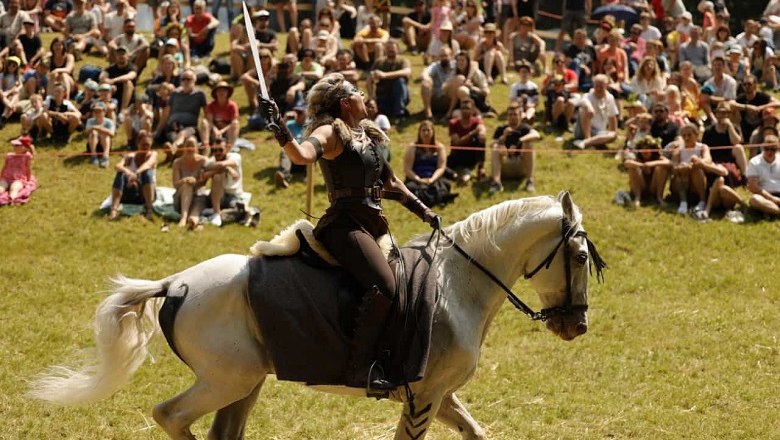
[319,138,386,210]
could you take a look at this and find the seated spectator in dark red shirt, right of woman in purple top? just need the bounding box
[447,100,485,184]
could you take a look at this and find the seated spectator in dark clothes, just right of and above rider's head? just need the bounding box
[369,40,412,124]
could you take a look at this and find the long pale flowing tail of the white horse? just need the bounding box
[28,275,170,405]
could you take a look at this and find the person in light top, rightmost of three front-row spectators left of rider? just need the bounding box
[203,138,244,227]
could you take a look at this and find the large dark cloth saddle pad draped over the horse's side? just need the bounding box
[247,248,437,385]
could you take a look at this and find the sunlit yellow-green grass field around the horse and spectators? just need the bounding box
[0,31,780,440]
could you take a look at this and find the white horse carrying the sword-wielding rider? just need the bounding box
[30,193,604,440]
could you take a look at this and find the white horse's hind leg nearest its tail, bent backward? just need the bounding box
[152,375,265,440]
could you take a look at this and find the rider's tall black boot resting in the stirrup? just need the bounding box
[346,287,395,398]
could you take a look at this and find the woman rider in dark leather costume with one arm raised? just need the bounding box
[260,73,441,396]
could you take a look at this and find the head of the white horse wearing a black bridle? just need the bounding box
[525,192,606,341]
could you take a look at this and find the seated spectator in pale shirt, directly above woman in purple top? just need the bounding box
[421,48,458,119]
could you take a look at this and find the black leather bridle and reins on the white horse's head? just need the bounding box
[439,217,607,321]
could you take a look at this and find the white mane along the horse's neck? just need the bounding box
[407,196,582,253]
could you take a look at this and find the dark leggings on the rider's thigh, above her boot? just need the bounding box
[318,211,395,299]
